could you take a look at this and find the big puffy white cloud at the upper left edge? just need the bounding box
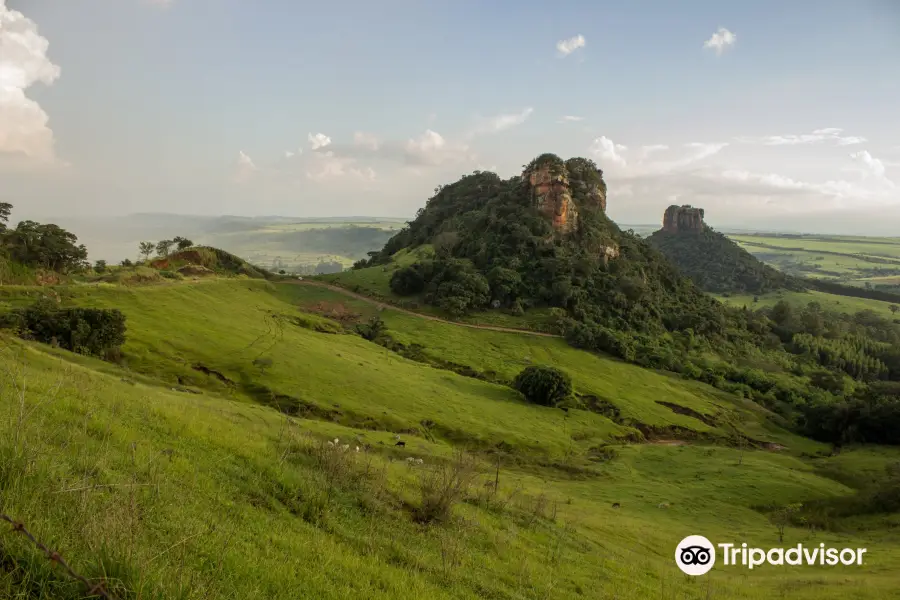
[0,0,60,162]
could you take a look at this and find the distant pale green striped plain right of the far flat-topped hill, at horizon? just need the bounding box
[728,234,900,286]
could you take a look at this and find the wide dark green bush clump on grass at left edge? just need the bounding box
[2,298,125,357]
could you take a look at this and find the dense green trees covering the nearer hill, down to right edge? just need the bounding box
[356,155,900,444]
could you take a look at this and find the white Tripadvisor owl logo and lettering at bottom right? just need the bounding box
[675,535,866,575]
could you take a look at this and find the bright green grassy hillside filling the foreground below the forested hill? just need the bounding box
[0,278,900,600]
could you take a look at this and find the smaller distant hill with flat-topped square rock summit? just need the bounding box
[647,206,803,294]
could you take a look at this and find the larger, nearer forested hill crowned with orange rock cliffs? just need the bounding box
[357,154,723,335]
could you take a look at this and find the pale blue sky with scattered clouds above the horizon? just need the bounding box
[0,0,900,235]
